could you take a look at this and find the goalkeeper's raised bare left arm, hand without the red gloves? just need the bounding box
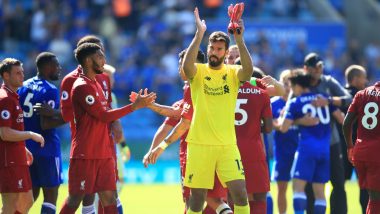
[182,8,207,80]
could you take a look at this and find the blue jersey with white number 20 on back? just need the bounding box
[285,93,337,152]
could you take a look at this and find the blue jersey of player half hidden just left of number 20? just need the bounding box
[271,97,299,154]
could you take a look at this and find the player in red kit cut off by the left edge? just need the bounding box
[0,58,45,214]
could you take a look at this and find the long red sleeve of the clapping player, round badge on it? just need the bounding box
[72,84,132,123]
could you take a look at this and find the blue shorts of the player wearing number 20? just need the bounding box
[292,151,330,183]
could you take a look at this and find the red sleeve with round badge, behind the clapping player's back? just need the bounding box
[60,78,74,122]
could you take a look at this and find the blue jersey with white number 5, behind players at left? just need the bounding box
[18,76,61,157]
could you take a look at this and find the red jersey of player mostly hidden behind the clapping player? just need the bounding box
[60,66,112,138]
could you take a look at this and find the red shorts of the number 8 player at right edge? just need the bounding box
[354,161,380,191]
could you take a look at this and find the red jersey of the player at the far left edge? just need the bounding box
[0,84,27,167]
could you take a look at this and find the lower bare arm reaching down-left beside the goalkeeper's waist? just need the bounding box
[149,117,191,164]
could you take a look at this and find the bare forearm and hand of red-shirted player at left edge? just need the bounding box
[0,126,45,147]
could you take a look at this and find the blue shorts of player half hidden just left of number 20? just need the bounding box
[272,152,294,181]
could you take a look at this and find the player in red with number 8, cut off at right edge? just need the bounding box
[343,82,380,214]
